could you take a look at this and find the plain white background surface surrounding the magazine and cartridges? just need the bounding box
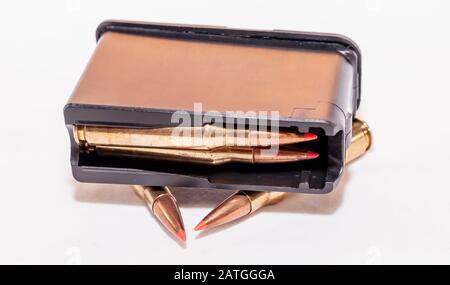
[0,0,450,264]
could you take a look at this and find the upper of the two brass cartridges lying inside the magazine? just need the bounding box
[73,125,317,150]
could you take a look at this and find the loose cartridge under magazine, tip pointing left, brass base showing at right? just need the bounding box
[195,119,372,231]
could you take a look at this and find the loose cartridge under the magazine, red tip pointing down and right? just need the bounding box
[133,185,186,241]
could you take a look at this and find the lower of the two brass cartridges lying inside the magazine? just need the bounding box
[95,145,319,165]
